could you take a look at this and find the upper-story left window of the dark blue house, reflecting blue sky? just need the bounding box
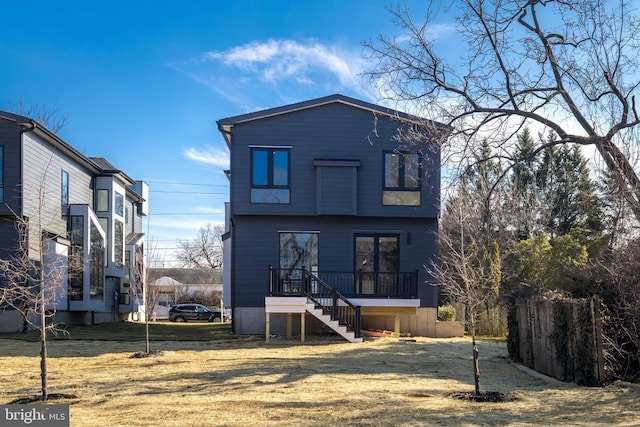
[251,147,291,203]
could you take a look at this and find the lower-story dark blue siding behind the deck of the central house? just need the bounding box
[232,216,438,307]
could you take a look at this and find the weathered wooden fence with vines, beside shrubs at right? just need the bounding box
[508,297,604,385]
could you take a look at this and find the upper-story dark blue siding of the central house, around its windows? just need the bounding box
[231,103,440,218]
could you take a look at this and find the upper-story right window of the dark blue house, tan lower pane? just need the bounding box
[382,151,422,206]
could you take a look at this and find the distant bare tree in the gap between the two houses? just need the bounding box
[177,224,224,268]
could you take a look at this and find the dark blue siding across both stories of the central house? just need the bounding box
[218,95,440,333]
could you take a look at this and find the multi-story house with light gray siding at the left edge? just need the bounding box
[0,111,148,331]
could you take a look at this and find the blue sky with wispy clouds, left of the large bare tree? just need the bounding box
[0,0,432,266]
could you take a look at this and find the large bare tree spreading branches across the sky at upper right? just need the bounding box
[365,0,640,224]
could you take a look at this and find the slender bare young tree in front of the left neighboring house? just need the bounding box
[0,168,75,400]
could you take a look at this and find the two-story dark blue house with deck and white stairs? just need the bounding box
[217,95,440,341]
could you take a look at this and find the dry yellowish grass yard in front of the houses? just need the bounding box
[0,323,640,426]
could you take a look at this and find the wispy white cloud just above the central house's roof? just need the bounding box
[170,39,375,105]
